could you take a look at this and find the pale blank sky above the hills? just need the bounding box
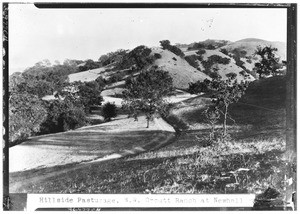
[9,4,287,73]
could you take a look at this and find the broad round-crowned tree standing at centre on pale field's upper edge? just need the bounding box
[123,69,173,127]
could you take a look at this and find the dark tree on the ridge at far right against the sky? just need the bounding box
[254,46,282,77]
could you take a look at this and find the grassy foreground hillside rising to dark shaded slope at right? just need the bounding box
[8,77,295,202]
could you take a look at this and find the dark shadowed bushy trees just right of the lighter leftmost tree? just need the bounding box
[40,97,88,134]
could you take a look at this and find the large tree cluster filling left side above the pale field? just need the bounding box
[9,63,104,145]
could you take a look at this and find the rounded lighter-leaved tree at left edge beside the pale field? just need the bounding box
[8,91,47,146]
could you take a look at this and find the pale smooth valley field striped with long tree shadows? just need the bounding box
[9,115,174,172]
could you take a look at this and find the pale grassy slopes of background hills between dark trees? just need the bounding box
[69,38,286,96]
